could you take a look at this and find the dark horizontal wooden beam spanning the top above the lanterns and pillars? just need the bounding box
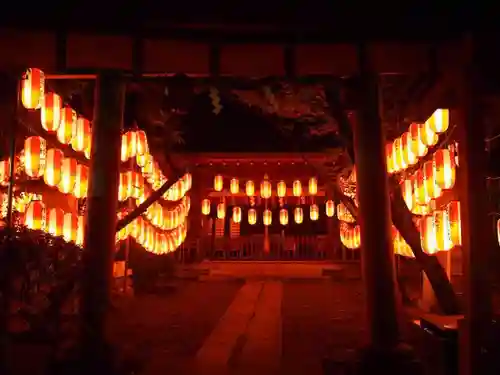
[0,29,448,78]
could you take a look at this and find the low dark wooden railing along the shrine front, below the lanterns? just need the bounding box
[178,235,359,262]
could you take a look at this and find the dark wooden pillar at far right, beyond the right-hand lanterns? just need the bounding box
[456,37,497,375]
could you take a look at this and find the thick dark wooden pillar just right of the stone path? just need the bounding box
[353,46,418,374]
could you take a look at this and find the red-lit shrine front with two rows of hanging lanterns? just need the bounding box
[185,153,359,261]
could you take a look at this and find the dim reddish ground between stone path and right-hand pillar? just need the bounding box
[282,280,363,375]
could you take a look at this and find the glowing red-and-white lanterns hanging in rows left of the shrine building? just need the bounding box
[15,68,192,253]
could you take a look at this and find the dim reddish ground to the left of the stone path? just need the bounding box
[110,281,242,374]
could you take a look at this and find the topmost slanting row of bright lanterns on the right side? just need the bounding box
[386,108,450,173]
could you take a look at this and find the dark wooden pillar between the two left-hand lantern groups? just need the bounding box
[81,71,125,373]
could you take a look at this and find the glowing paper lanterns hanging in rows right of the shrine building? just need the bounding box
[337,109,466,257]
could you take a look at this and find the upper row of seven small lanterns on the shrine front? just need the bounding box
[214,175,318,199]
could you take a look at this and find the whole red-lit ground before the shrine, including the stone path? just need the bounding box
[108,279,363,375]
